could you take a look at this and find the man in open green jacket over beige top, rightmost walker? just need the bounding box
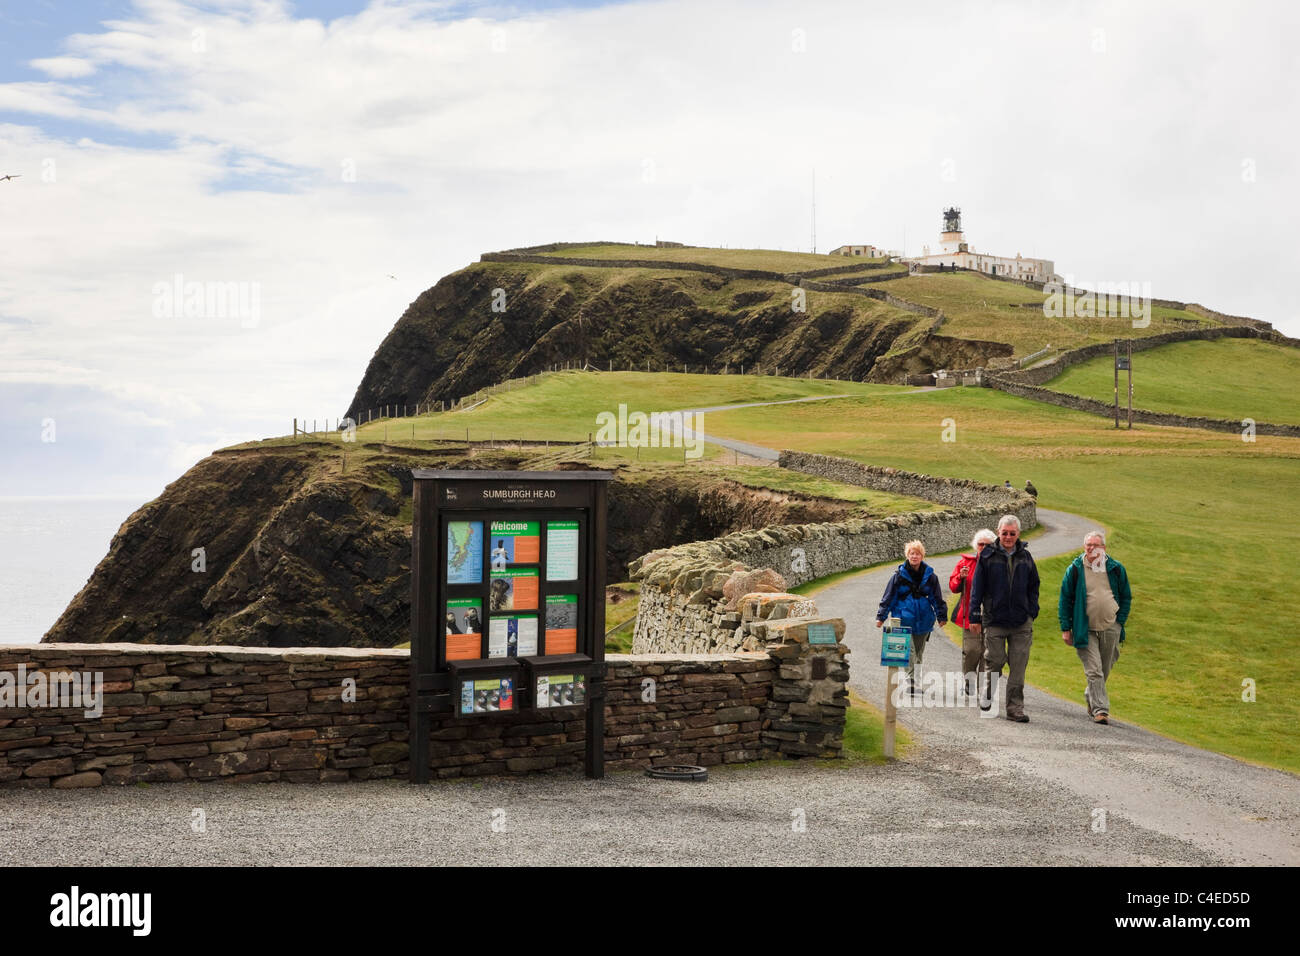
[1057,531,1132,723]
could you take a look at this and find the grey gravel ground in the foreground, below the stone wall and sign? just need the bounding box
[0,748,1218,866]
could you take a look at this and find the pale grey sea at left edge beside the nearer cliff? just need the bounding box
[0,496,148,644]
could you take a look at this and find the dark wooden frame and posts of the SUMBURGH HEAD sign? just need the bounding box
[410,468,614,783]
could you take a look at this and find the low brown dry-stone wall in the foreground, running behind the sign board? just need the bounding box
[0,637,848,788]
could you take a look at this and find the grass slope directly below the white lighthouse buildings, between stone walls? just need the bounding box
[874,272,1213,355]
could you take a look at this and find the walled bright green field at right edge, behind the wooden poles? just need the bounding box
[1047,338,1300,424]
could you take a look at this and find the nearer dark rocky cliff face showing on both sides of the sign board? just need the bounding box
[43,442,852,646]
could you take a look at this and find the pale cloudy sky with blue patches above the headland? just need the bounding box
[0,0,1300,501]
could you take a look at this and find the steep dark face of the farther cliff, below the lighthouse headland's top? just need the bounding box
[347,263,924,419]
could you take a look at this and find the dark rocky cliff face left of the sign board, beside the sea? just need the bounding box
[43,446,411,646]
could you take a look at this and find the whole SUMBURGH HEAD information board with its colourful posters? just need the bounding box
[411,468,614,783]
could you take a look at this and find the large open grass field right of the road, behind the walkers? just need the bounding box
[709,389,1300,771]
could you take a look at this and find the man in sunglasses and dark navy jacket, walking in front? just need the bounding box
[970,515,1039,723]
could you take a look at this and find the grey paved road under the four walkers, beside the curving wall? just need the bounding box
[816,509,1300,866]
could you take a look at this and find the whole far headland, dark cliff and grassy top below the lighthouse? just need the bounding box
[346,243,1242,419]
